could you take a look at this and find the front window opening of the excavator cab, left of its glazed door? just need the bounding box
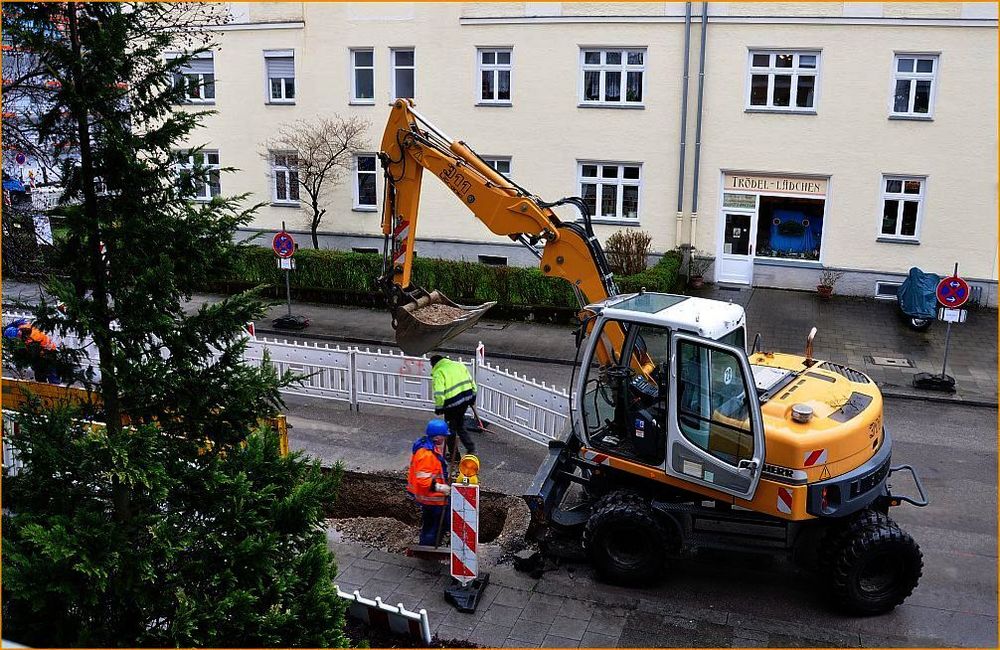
[581,323,670,466]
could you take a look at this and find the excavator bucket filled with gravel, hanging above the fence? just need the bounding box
[394,291,496,356]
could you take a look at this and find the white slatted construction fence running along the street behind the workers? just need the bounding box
[3,311,570,450]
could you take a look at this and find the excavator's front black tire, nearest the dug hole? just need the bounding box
[583,490,673,586]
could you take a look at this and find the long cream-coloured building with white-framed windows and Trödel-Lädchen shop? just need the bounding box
[182,2,998,304]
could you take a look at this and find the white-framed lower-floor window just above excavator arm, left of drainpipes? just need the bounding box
[577,160,642,223]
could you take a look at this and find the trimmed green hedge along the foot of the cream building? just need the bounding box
[221,246,680,310]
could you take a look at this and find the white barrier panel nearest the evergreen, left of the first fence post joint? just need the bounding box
[246,338,353,402]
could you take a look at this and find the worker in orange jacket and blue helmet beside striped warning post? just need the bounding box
[406,418,454,546]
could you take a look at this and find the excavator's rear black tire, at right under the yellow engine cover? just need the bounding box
[830,513,924,616]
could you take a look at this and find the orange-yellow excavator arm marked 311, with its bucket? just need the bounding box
[379,99,624,356]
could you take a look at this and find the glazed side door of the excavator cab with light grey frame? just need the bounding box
[666,334,764,499]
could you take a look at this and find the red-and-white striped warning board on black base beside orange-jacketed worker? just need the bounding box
[444,480,490,612]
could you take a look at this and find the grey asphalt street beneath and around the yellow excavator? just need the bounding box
[288,392,997,647]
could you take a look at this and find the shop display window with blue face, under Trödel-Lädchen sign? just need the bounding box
[756,195,825,261]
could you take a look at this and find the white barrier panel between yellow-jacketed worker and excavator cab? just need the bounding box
[476,363,569,445]
